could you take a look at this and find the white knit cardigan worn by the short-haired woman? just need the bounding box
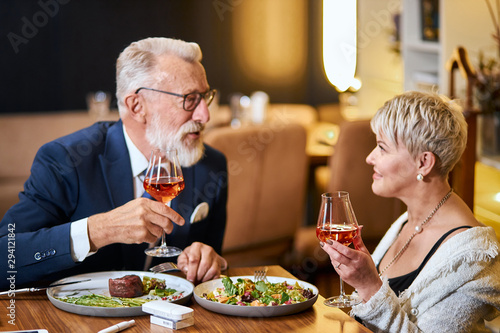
[350,213,500,333]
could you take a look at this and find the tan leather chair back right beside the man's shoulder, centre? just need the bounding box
[205,123,308,266]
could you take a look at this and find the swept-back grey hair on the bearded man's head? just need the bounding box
[116,37,202,114]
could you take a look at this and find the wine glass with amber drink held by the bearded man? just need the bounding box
[144,148,184,257]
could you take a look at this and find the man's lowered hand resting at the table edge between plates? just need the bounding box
[177,242,227,284]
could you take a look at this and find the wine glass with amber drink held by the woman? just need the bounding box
[316,191,361,308]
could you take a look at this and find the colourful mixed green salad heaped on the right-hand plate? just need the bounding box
[202,277,315,306]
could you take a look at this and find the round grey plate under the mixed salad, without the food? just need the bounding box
[194,276,318,317]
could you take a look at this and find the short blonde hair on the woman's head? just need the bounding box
[371,91,467,177]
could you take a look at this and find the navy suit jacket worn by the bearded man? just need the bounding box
[0,121,227,289]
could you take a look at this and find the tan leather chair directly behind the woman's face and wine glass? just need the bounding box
[294,120,404,266]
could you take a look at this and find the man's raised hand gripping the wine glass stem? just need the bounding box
[87,198,184,251]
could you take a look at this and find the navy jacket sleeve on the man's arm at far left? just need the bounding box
[0,143,78,289]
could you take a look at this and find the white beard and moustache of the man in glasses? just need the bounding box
[146,113,205,167]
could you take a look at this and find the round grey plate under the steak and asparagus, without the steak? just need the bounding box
[47,271,194,317]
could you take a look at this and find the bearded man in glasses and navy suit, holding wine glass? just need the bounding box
[0,38,227,288]
